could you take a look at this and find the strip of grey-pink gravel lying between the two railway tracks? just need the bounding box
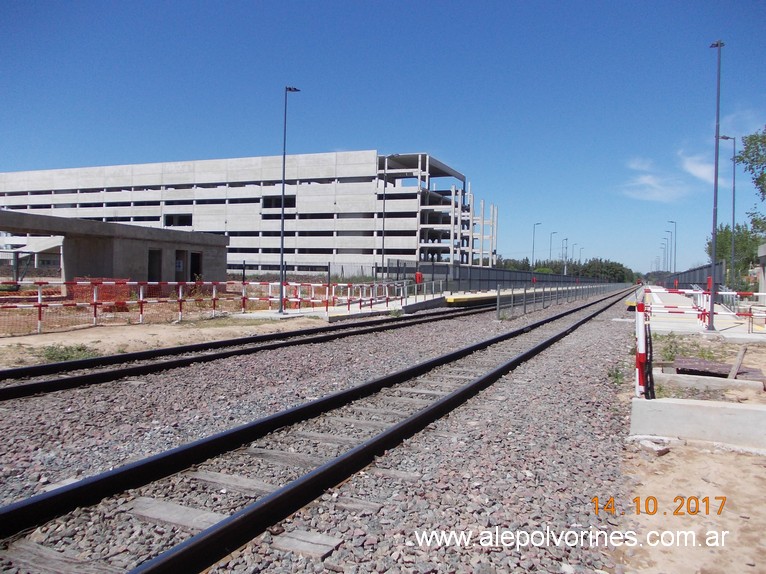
[0,305,565,504]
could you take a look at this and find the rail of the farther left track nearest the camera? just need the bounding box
[0,309,498,402]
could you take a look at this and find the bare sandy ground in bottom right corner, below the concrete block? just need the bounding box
[617,445,766,574]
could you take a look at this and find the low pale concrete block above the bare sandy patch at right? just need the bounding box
[630,399,766,449]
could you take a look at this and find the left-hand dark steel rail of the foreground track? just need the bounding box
[0,293,622,538]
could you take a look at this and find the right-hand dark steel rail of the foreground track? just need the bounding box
[131,292,628,574]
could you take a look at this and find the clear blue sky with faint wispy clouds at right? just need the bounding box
[0,0,766,272]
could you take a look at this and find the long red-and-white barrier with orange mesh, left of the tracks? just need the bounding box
[0,279,432,334]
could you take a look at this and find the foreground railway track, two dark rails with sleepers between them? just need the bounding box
[0,294,622,572]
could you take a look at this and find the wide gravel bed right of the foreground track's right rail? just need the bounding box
[208,305,633,573]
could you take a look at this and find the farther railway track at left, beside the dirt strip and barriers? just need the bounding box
[0,303,498,401]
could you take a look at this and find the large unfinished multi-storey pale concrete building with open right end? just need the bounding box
[0,150,497,271]
